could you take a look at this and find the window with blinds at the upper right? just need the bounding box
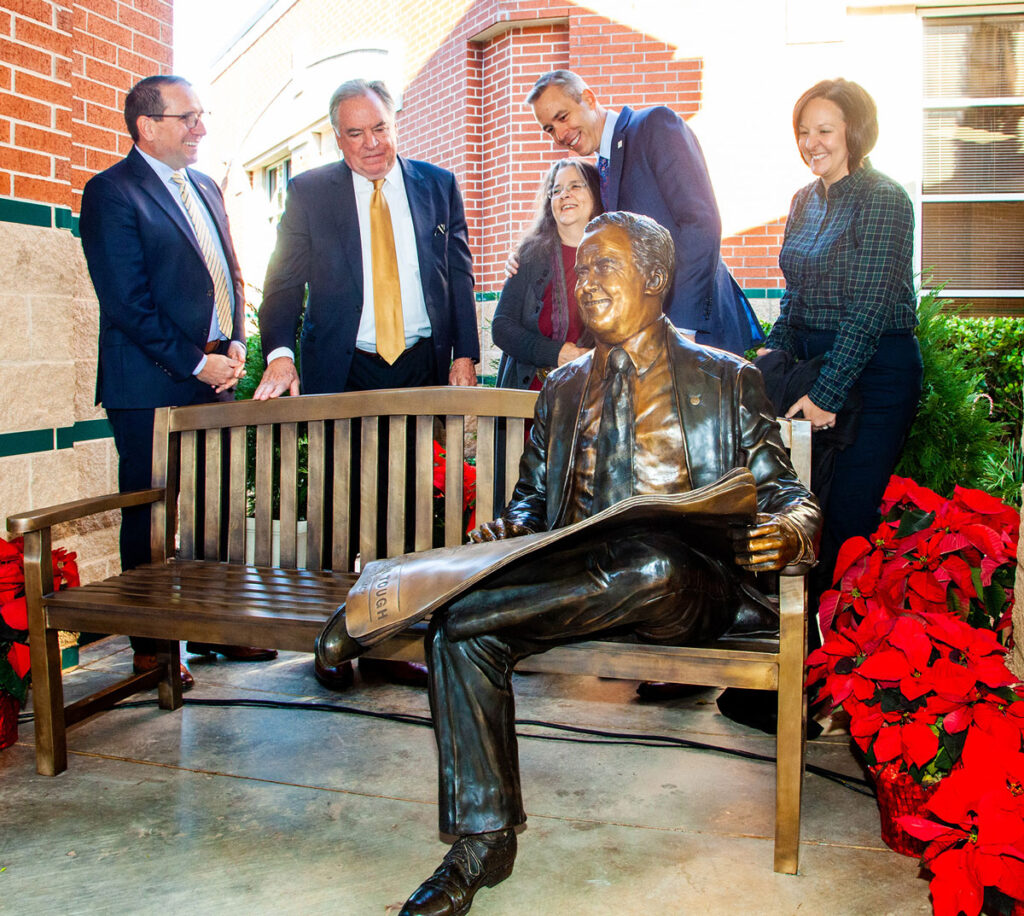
[921,15,1024,315]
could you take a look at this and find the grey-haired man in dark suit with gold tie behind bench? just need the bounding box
[254,80,480,689]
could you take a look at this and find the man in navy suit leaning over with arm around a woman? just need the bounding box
[526,70,764,356]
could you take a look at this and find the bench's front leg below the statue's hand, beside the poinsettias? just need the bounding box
[775,576,807,875]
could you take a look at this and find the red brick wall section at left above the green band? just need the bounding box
[0,0,172,212]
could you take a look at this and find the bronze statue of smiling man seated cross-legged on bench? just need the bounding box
[317,213,820,916]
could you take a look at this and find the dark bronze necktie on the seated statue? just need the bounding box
[593,347,635,513]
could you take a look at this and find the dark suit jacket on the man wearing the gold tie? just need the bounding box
[259,157,480,394]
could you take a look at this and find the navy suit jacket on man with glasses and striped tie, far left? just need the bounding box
[79,147,245,408]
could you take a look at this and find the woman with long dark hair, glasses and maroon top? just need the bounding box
[492,159,602,390]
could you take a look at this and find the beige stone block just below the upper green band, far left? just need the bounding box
[0,223,81,296]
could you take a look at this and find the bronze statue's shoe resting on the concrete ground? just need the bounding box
[398,828,516,916]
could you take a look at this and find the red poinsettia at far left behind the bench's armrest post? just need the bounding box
[0,537,79,705]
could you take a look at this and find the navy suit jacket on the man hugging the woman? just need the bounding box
[603,106,764,356]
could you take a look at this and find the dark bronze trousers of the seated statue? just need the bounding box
[426,528,735,835]
